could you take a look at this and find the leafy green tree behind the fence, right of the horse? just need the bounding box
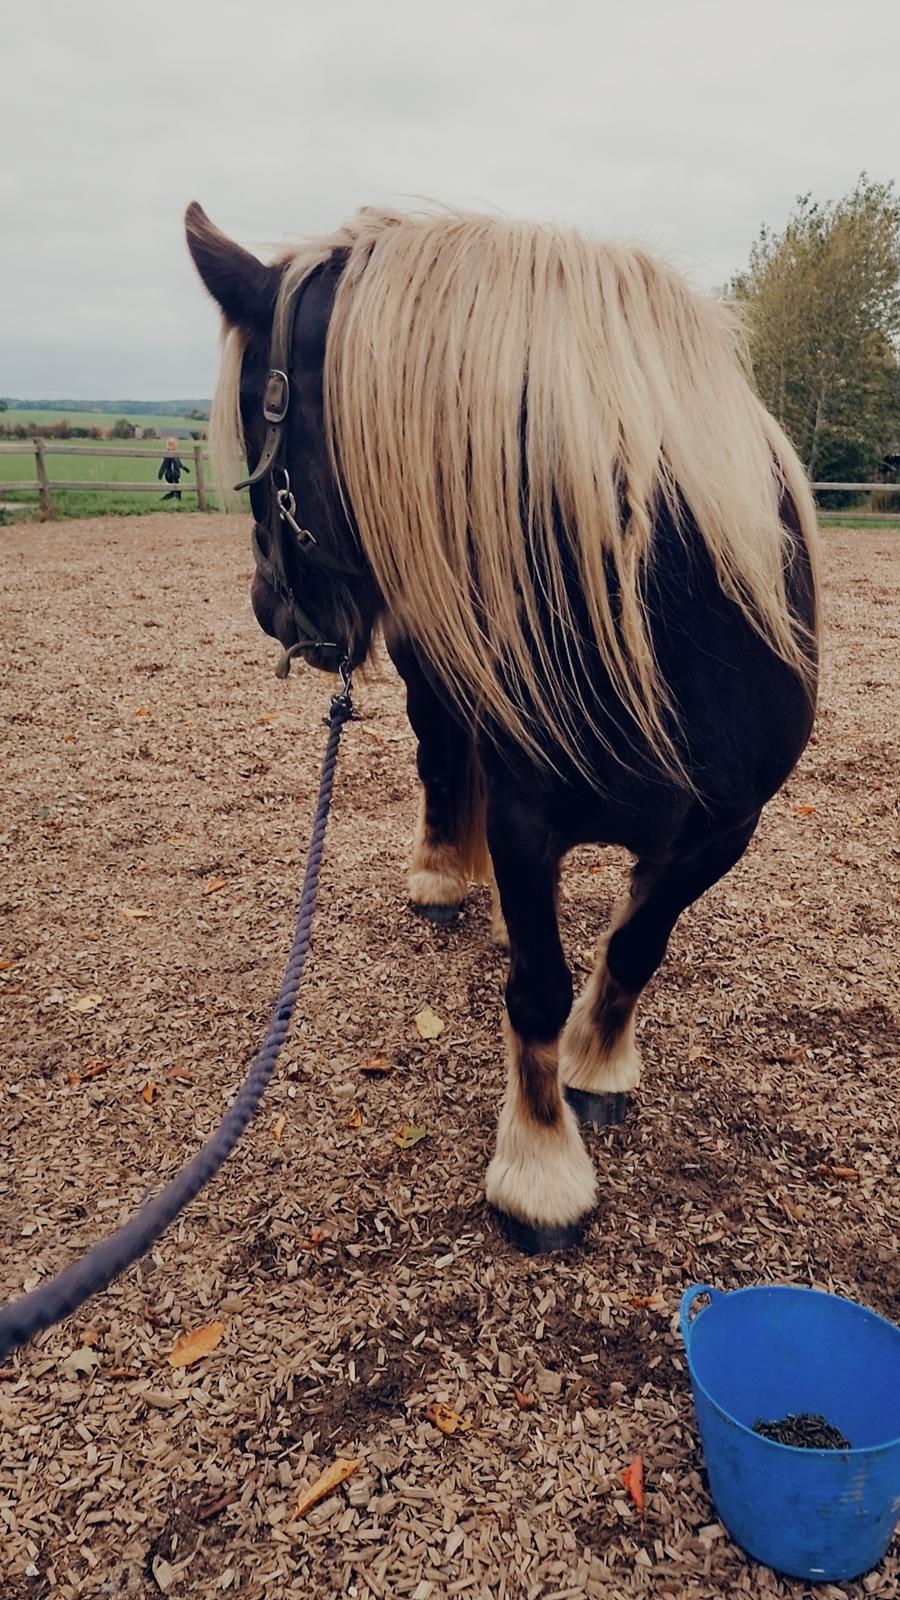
[730,173,900,482]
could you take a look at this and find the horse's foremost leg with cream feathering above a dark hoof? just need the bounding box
[485,786,596,1253]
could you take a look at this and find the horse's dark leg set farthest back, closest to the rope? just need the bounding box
[388,640,488,923]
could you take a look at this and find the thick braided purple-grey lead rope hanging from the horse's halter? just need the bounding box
[0,690,352,1360]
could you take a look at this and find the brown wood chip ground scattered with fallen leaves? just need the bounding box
[0,514,900,1600]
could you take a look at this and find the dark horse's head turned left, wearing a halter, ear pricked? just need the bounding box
[186,202,380,672]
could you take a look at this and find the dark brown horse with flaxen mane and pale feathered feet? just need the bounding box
[186,202,818,1253]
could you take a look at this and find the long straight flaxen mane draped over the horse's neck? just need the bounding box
[211,210,815,779]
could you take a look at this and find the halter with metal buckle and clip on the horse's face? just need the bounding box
[234,278,360,678]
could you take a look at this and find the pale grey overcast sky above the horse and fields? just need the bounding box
[7,0,900,398]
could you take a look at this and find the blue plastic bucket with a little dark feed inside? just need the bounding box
[681,1283,900,1582]
